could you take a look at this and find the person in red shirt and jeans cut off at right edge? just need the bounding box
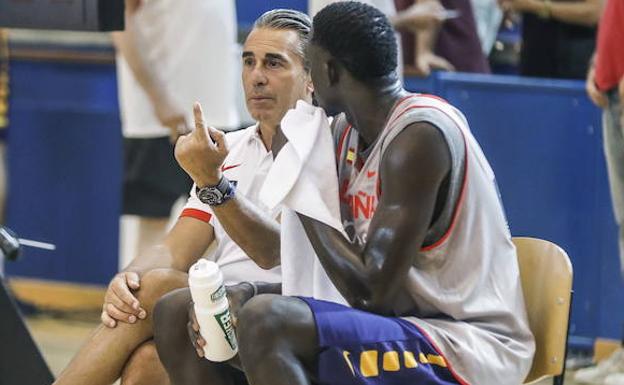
[574,0,624,385]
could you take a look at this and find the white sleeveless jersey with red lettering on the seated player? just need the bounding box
[334,95,535,385]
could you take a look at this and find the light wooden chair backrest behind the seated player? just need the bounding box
[513,238,572,383]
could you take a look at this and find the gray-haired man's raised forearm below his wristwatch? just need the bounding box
[212,195,280,269]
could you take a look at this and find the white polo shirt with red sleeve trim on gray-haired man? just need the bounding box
[180,125,281,285]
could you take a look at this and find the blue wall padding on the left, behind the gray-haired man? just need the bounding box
[7,61,122,284]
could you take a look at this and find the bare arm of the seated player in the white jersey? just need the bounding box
[299,123,451,314]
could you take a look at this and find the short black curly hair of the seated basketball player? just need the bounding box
[312,1,398,80]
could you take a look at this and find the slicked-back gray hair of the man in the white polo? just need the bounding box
[253,9,312,69]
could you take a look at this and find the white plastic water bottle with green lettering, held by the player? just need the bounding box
[189,259,238,362]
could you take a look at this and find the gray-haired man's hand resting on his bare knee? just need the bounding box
[101,271,147,328]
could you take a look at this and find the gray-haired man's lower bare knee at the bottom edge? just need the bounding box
[121,341,169,385]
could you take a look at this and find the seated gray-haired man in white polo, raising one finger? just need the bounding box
[56,10,313,385]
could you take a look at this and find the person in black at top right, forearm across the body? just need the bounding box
[500,0,604,79]
